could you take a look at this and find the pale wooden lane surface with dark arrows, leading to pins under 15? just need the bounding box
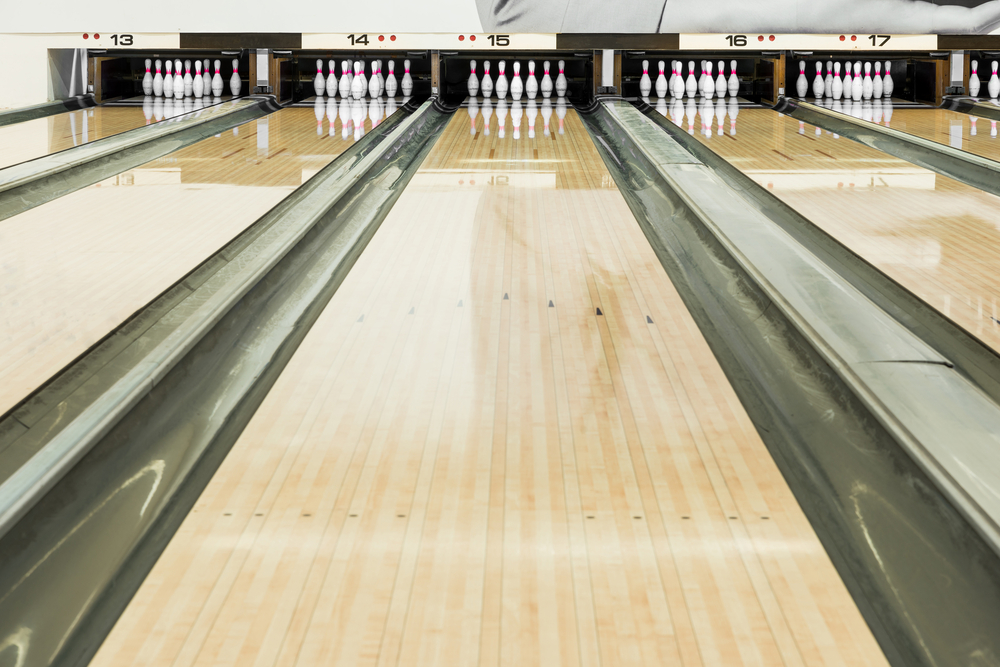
[92,110,886,667]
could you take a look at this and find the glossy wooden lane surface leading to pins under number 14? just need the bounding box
[0,109,396,413]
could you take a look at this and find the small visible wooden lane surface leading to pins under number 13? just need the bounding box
[0,107,153,169]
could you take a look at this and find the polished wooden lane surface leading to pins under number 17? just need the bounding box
[835,102,1000,160]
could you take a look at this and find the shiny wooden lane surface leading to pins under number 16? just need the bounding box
[680,103,1000,351]
